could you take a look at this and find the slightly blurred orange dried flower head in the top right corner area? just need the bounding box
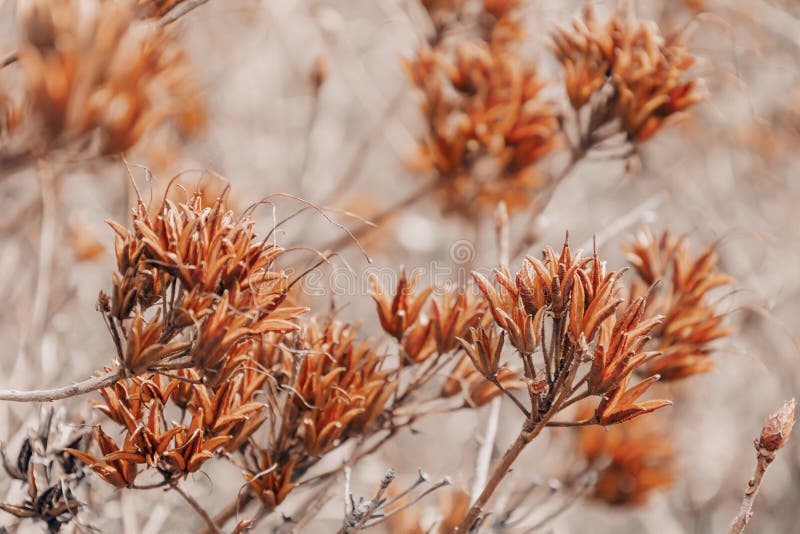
[554,6,704,142]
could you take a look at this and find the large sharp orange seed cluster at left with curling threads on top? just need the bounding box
[104,188,305,379]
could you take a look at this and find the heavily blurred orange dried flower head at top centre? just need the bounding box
[405,41,560,216]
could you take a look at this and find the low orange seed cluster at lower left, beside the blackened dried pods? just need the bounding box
[70,368,266,487]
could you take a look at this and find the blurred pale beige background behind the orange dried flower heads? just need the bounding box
[0,0,800,534]
